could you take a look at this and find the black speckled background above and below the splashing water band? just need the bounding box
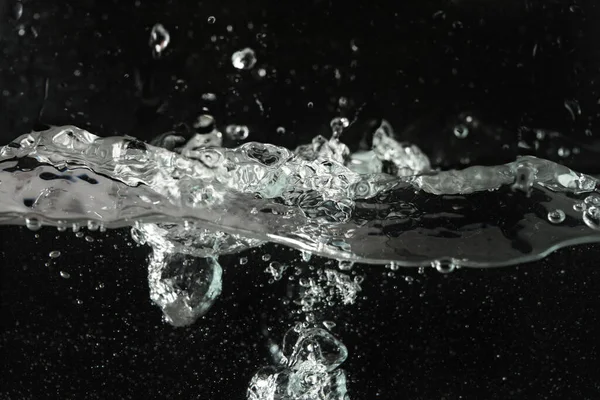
[0,0,600,400]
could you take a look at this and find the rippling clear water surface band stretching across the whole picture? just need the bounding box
[0,126,600,267]
